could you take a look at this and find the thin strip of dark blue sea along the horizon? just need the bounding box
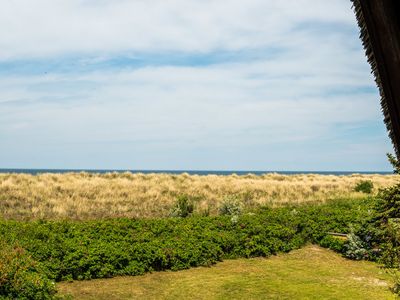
[0,168,393,175]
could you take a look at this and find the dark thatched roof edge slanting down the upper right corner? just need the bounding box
[351,0,400,158]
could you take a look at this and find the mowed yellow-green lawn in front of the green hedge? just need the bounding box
[58,246,396,300]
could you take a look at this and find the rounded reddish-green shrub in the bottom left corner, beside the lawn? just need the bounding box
[0,241,55,299]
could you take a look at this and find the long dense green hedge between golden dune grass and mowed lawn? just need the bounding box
[0,199,371,299]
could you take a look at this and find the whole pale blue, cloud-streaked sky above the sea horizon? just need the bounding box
[0,0,393,171]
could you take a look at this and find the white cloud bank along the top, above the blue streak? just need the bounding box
[0,0,354,60]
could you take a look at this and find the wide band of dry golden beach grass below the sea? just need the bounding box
[0,173,400,220]
